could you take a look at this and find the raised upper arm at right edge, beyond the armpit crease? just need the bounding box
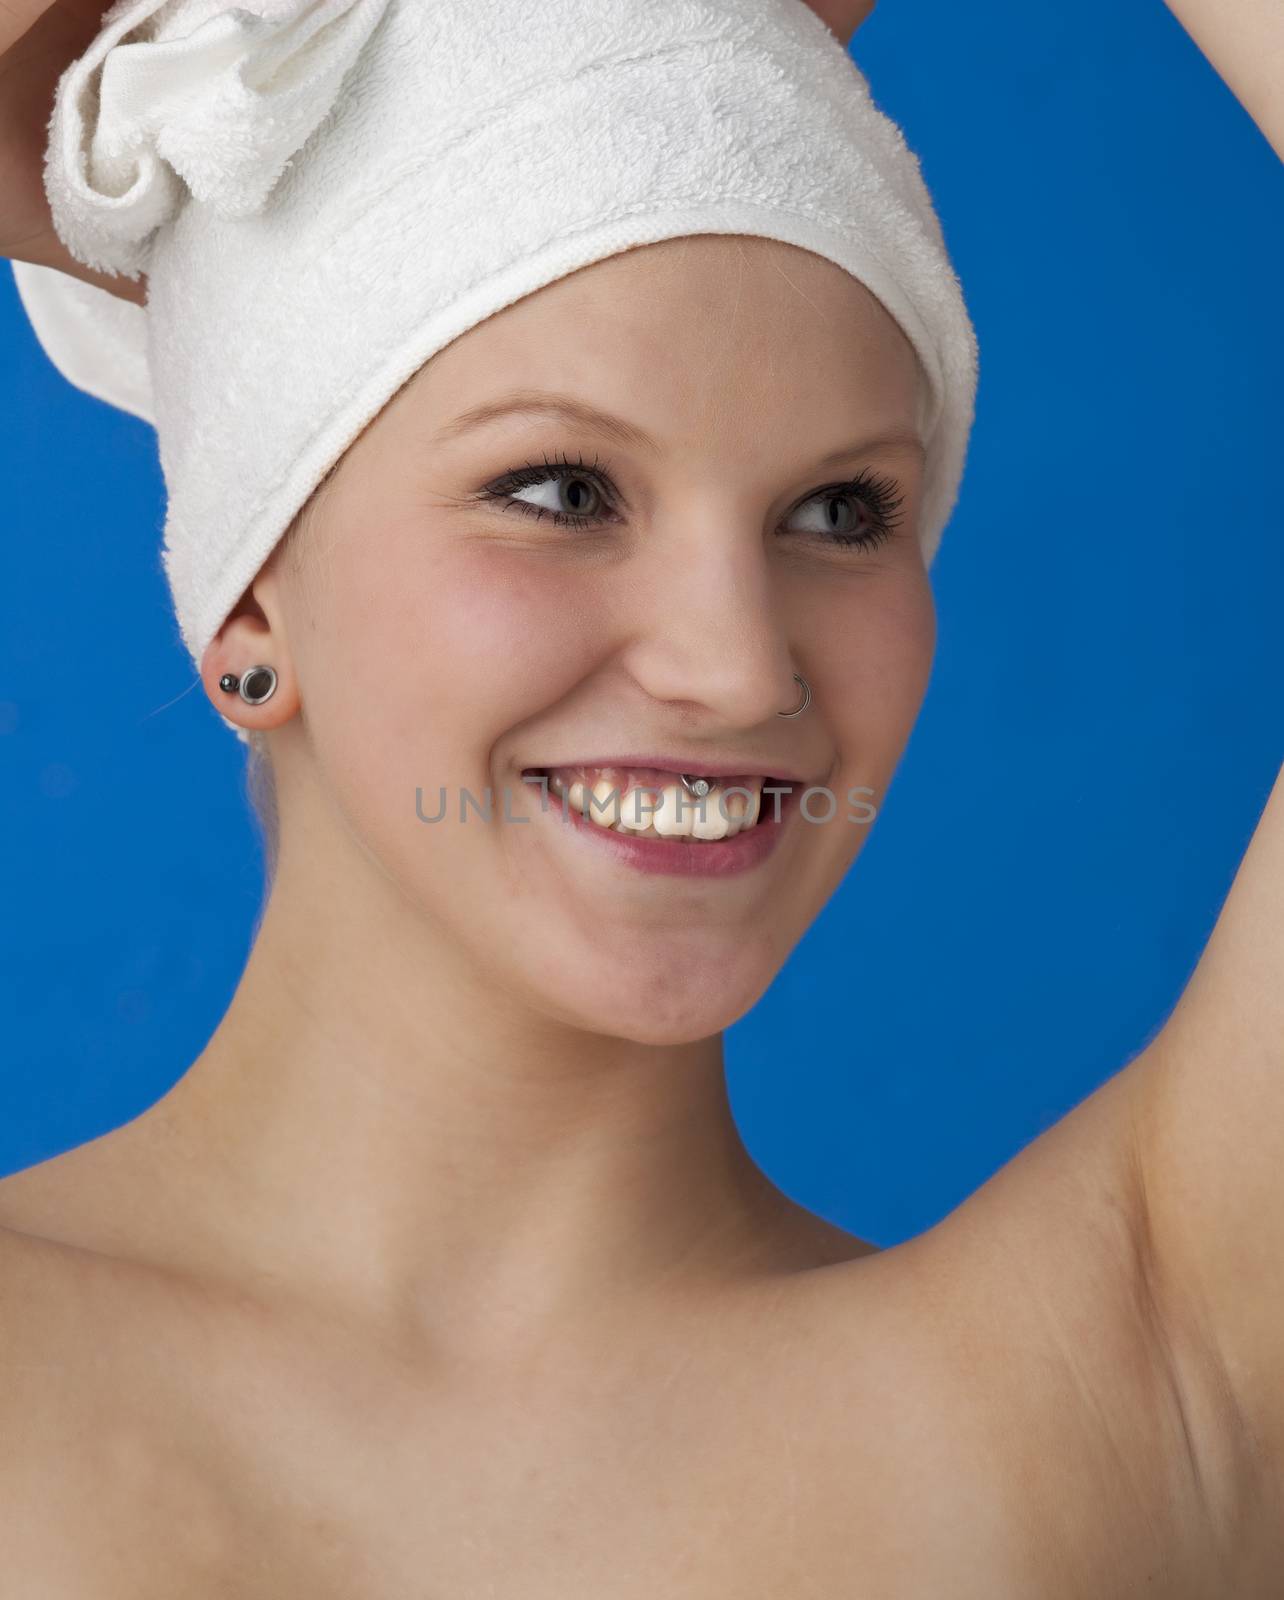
[1124,770,1284,1584]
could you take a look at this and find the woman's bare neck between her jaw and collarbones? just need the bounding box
[140,819,834,1355]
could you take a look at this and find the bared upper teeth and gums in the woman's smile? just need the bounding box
[522,766,796,846]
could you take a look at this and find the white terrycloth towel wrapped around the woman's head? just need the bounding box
[16,0,977,742]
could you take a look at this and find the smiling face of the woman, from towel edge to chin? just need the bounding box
[244,235,935,1043]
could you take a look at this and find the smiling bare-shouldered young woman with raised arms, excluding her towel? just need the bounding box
[0,0,1284,1600]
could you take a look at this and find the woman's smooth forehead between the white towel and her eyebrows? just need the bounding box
[390,234,927,437]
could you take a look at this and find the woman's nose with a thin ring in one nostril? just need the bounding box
[614,522,799,728]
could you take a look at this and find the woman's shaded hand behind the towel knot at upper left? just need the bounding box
[0,0,147,306]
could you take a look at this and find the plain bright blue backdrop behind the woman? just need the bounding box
[0,0,1284,1245]
